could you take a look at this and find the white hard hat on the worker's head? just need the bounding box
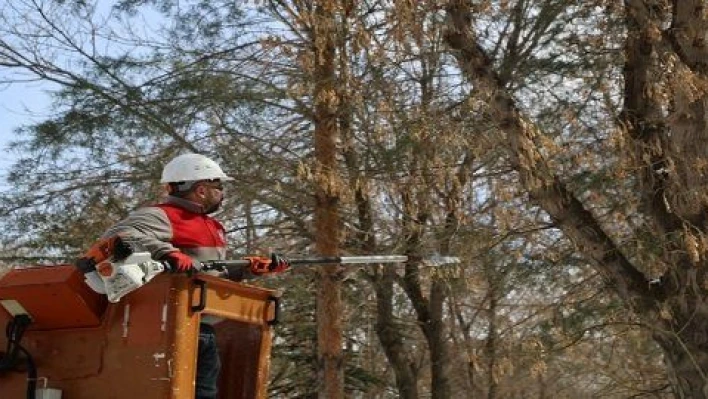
[160,154,233,183]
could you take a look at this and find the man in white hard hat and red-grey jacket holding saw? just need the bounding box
[103,154,289,399]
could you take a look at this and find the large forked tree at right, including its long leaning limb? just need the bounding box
[446,0,708,398]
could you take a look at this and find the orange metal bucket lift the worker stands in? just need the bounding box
[0,265,279,399]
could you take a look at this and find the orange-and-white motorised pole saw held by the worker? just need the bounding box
[75,236,460,303]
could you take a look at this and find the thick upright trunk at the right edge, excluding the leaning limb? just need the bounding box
[620,0,708,398]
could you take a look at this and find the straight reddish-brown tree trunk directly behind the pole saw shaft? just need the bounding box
[312,0,344,399]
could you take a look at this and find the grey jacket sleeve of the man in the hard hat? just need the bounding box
[102,207,177,259]
